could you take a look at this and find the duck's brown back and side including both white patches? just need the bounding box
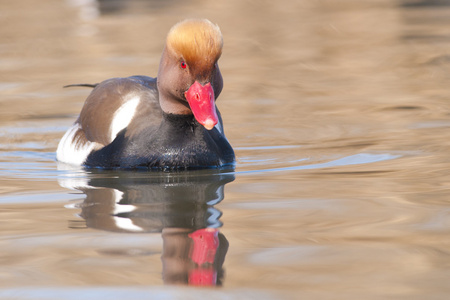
[56,76,162,165]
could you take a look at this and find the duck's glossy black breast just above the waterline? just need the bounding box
[85,114,234,170]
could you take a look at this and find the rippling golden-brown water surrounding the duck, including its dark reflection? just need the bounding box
[0,0,450,299]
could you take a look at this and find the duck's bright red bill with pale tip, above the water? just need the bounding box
[184,81,219,130]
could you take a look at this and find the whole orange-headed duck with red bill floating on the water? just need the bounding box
[56,19,235,170]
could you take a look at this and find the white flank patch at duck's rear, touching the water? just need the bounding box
[56,123,97,166]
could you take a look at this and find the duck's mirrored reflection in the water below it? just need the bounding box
[61,171,234,285]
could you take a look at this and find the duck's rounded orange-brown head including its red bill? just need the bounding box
[158,19,223,130]
